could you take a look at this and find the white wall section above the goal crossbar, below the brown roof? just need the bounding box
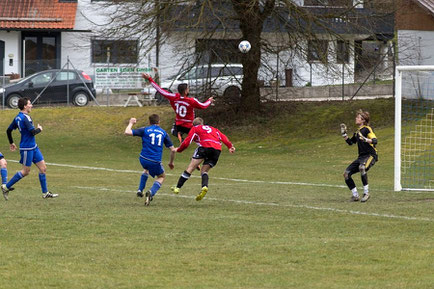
[398,30,434,65]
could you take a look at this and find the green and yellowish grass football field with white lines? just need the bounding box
[0,100,434,289]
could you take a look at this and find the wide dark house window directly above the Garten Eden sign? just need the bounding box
[92,39,138,63]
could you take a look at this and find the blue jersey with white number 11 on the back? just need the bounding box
[133,125,173,162]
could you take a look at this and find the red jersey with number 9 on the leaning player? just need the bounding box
[178,125,232,152]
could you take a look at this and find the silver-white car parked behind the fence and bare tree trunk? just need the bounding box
[144,64,243,104]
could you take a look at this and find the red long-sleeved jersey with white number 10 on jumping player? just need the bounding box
[149,78,211,128]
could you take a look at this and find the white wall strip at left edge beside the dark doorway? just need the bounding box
[0,30,21,74]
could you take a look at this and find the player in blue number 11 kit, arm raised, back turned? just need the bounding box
[125,114,176,206]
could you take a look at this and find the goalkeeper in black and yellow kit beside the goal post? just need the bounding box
[341,110,378,202]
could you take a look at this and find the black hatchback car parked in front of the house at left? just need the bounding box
[0,69,95,108]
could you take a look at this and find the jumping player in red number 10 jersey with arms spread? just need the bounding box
[142,73,214,143]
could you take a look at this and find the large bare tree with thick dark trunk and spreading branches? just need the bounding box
[90,0,396,112]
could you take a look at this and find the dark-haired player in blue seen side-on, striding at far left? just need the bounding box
[2,97,58,199]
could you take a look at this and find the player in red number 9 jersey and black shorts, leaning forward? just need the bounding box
[172,117,235,201]
